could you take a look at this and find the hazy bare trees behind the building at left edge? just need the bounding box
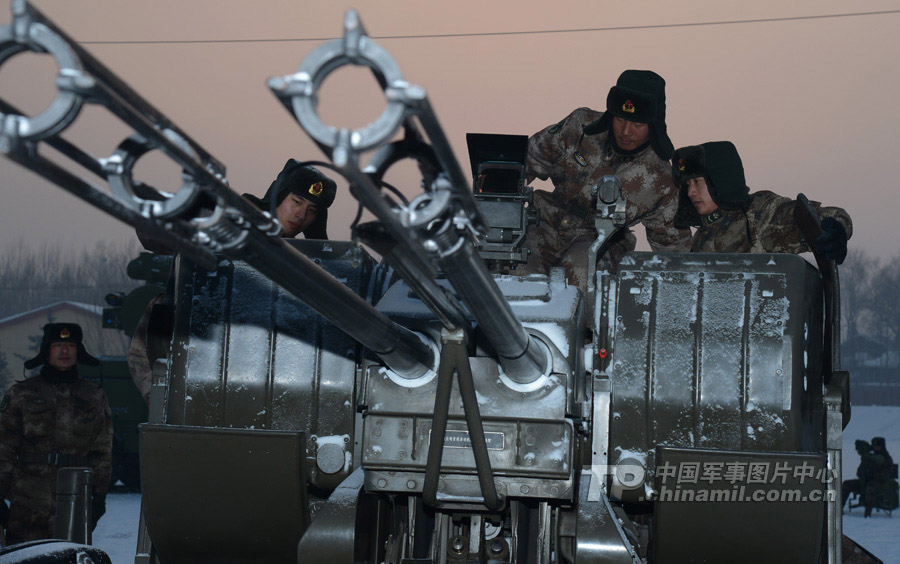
[0,239,141,319]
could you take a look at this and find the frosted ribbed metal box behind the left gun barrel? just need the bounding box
[163,241,385,489]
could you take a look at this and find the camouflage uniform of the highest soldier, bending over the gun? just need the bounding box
[526,108,691,289]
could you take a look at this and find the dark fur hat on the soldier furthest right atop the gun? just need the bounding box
[672,141,751,229]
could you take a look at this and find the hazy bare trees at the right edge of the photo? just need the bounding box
[839,250,900,347]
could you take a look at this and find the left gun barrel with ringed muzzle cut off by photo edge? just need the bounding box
[0,0,434,378]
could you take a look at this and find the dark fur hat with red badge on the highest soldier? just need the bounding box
[583,70,674,161]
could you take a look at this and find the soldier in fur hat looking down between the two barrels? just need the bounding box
[244,159,337,239]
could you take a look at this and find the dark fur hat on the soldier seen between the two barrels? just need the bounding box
[244,159,337,239]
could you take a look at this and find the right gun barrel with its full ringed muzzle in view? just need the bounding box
[269,11,550,383]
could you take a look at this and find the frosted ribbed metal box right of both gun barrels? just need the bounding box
[607,253,824,495]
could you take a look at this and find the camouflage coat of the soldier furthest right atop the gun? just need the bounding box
[691,190,853,253]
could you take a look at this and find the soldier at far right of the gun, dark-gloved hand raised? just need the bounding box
[672,141,853,264]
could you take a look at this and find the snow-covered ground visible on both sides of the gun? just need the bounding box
[94,406,900,564]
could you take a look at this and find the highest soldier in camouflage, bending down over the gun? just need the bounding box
[526,70,691,291]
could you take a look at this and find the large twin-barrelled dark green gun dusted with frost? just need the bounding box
[0,4,860,564]
